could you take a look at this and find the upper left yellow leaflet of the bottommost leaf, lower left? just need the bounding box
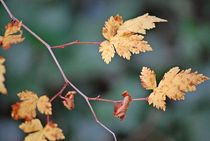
[19,119,43,133]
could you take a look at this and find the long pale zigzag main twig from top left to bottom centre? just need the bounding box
[0,0,117,141]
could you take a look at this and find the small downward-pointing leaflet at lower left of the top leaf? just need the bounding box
[99,41,115,64]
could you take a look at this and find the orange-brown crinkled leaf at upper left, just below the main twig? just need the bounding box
[0,21,24,49]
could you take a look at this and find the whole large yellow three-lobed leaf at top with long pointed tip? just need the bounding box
[99,14,166,64]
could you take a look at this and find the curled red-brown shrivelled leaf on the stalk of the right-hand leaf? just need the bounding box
[114,91,132,120]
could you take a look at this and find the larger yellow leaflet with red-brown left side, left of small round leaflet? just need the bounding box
[12,91,38,120]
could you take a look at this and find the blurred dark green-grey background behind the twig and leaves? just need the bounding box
[0,0,210,141]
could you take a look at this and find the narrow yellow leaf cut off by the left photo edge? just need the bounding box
[0,56,7,94]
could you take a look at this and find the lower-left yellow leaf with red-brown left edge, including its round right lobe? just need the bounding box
[11,91,52,121]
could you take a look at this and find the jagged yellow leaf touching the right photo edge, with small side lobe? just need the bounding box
[142,67,209,111]
